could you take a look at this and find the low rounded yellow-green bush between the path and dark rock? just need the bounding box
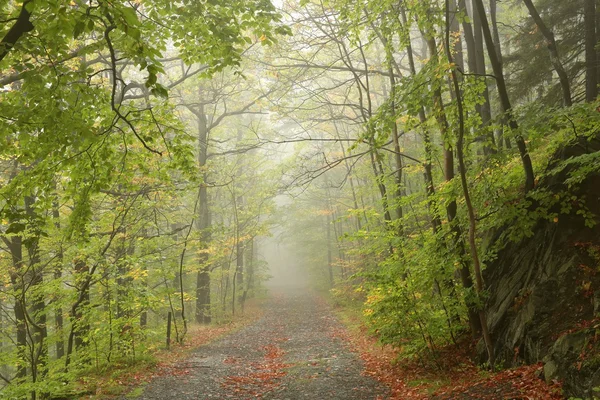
[363,230,464,357]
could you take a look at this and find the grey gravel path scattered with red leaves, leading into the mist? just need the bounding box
[130,287,387,400]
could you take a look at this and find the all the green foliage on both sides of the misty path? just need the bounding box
[0,0,600,398]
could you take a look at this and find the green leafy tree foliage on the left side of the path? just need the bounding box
[0,0,289,398]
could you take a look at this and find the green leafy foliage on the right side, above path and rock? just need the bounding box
[276,0,600,370]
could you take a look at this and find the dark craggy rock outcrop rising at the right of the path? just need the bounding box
[484,140,600,398]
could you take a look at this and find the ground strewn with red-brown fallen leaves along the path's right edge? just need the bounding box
[337,308,564,400]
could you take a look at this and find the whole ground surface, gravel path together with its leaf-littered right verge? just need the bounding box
[110,288,562,400]
